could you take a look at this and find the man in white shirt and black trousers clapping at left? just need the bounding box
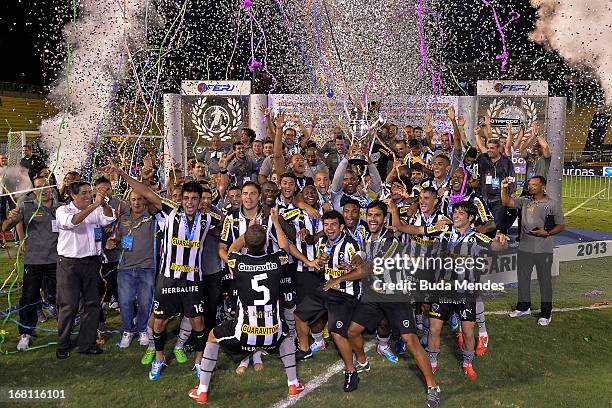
[55,181,115,359]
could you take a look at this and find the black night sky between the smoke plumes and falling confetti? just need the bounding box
[0,0,599,98]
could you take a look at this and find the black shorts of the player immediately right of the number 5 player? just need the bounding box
[295,286,359,337]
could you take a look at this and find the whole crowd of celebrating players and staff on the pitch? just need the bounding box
[9,103,563,407]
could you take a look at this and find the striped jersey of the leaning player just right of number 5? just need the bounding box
[317,232,365,298]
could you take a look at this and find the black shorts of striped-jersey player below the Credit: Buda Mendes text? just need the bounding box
[353,302,417,335]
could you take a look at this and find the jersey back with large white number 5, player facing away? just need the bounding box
[228,250,287,346]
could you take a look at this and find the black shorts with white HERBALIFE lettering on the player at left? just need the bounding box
[153,276,204,319]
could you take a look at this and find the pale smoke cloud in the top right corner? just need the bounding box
[530,0,612,104]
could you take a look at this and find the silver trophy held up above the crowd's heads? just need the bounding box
[345,102,385,166]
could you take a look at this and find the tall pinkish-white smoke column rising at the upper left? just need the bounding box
[40,0,145,180]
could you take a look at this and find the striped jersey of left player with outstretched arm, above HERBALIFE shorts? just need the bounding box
[158,200,221,281]
